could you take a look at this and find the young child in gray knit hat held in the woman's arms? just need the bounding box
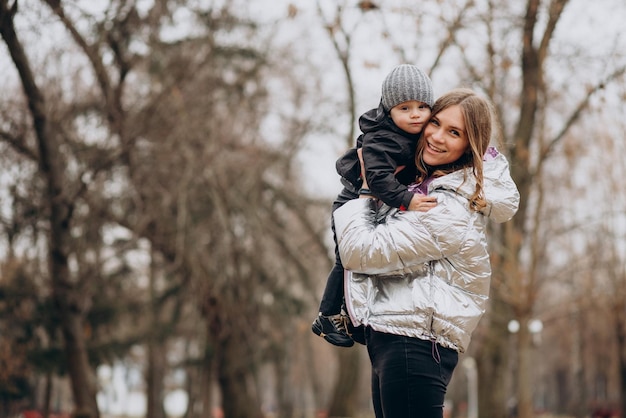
[311,64,436,347]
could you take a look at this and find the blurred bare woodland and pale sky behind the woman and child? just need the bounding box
[0,0,626,418]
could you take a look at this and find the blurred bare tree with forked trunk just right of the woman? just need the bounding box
[494,0,623,417]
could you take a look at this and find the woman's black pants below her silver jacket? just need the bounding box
[365,327,458,418]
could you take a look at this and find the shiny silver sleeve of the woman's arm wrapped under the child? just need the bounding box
[333,191,472,274]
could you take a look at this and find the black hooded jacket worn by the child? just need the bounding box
[336,105,419,208]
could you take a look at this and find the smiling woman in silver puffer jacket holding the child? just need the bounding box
[334,89,519,418]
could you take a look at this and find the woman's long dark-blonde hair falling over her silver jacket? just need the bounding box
[415,88,493,211]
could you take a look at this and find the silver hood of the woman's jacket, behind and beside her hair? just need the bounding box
[428,147,520,223]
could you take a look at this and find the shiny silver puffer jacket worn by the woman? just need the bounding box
[334,152,519,352]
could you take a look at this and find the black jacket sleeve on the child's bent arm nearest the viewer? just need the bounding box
[363,135,415,208]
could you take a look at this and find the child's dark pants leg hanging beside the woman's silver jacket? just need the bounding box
[319,187,359,315]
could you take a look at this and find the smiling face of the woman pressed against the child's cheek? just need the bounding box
[422,105,469,166]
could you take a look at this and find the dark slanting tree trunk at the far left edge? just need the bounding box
[0,0,99,418]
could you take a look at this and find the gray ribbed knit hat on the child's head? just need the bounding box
[381,64,435,112]
